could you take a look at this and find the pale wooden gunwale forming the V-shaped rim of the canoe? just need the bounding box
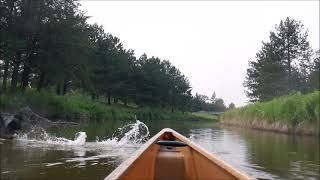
[105,128,255,180]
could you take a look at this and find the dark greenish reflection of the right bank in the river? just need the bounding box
[228,128,320,179]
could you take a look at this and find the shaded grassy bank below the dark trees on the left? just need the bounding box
[0,89,216,122]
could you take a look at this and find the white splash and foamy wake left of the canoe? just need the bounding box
[15,120,149,166]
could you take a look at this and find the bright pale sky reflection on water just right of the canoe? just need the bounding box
[189,128,277,179]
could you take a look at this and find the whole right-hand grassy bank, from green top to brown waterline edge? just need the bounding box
[222,91,320,135]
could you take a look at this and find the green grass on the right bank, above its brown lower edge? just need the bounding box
[223,91,320,132]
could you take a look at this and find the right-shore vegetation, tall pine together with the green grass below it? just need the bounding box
[230,18,320,134]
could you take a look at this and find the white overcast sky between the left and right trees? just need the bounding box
[81,1,319,106]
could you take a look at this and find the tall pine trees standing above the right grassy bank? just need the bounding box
[244,18,320,101]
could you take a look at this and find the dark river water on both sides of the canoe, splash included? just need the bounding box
[0,121,320,180]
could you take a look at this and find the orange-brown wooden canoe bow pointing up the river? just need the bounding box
[105,128,254,180]
